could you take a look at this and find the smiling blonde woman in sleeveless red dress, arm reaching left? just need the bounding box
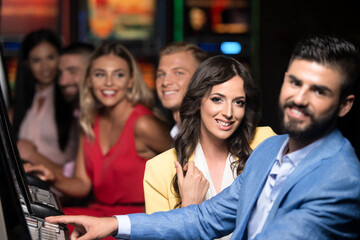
[27,42,172,234]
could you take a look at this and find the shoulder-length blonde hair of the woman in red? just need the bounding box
[79,42,154,139]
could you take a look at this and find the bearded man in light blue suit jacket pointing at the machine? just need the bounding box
[48,36,360,239]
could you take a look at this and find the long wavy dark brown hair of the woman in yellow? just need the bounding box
[172,56,261,207]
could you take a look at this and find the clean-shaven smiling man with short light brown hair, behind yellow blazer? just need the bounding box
[156,42,207,138]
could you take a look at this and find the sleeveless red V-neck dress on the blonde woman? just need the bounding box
[64,105,152,236]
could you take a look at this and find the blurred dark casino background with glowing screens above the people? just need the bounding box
[0,0,360,147]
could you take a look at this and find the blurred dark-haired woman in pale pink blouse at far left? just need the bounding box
[12,29,77,175]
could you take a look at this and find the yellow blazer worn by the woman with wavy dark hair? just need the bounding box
[144,127,276,214]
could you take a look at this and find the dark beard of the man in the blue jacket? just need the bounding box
[279,101,340,141]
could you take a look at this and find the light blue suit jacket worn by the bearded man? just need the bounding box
[129,130,360,240]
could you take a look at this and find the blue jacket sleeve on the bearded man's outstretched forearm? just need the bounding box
[129,175,242,239]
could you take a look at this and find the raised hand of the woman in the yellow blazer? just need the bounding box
[175,161,209,207]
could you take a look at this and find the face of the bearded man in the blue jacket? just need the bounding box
[280,59,344,144]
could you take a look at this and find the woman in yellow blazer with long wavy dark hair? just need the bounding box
[144,56,275,219]
